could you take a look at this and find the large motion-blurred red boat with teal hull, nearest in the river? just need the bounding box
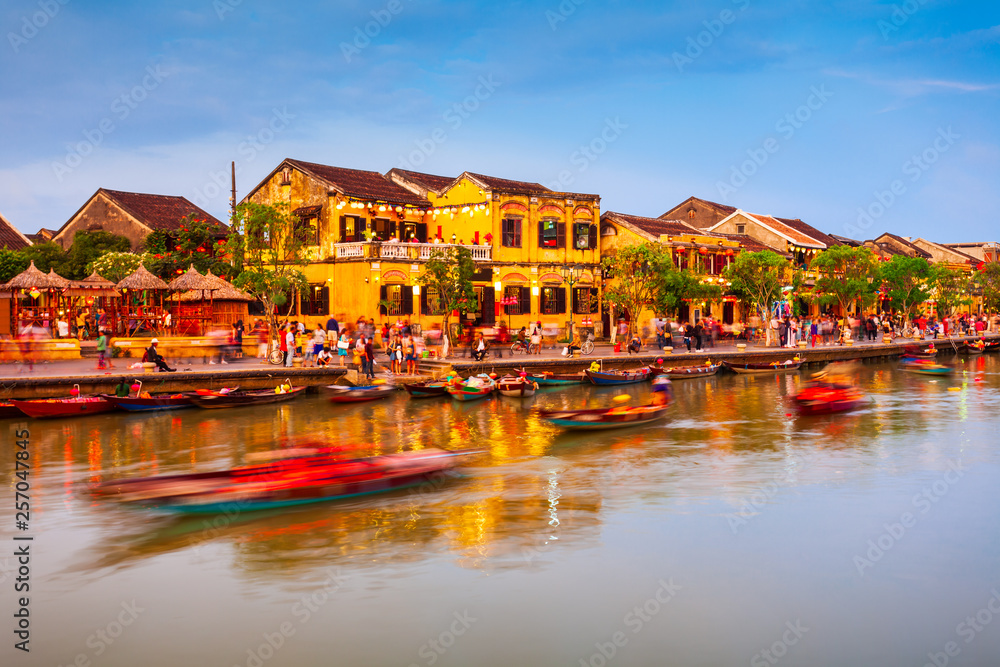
[90,449,481,514]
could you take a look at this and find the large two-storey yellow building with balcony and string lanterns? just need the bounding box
[246,159,600,335]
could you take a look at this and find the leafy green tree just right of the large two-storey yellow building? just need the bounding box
[601,243,670,337]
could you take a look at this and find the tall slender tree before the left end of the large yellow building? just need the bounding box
[225,202,309,353]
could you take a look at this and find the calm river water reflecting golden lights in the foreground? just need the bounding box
[0,356,1000,667]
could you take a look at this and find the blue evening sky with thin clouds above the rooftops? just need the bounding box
[0,0,1000,243]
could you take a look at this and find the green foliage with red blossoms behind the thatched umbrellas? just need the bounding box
[146,213,233,281]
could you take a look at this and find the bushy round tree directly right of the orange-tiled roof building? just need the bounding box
[809,245,879,316]
